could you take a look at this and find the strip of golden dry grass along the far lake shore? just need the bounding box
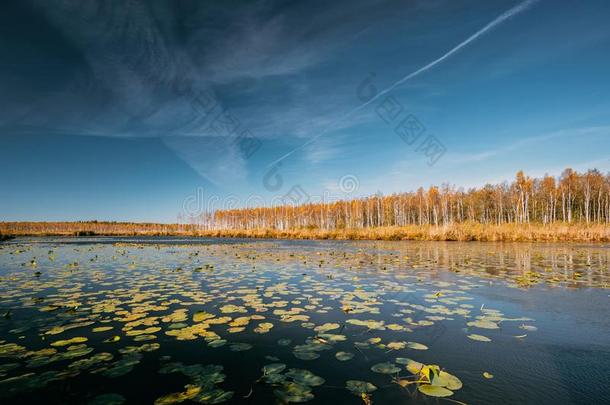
[0,222,610,242]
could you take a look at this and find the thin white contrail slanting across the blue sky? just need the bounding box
[269,0,539,166]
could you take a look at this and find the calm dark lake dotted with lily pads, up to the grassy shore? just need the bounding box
[0,237,610,404]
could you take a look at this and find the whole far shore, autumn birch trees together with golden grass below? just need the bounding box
[0,169,610,241]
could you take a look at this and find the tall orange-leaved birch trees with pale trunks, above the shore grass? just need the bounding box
[197,169,610,231]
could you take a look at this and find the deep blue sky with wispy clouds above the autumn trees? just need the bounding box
[0,0,610,222]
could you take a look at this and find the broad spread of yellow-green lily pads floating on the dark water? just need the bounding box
[0,238,560,404]
